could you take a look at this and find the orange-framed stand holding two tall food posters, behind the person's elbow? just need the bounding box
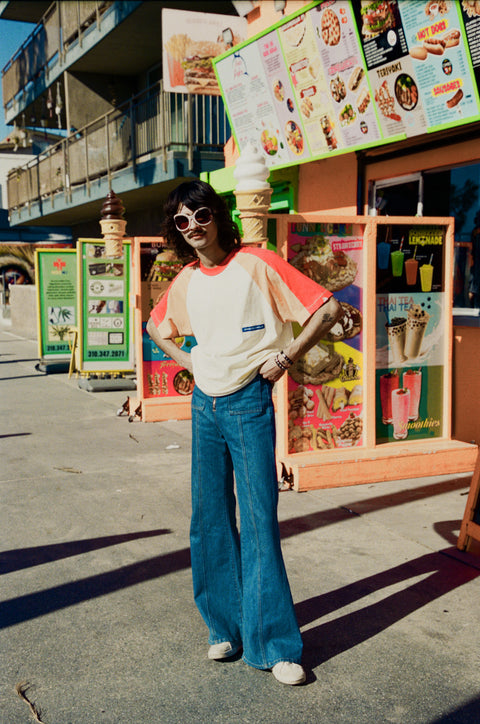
[276,213,477,491]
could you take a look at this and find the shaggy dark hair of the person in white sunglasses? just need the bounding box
[161,179,242,261]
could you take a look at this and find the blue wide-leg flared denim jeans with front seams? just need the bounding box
[190,375,302,669]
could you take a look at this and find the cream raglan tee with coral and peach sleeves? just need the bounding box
[151,247,331,396]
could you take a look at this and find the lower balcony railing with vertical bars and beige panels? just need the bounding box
[7,81,231,211]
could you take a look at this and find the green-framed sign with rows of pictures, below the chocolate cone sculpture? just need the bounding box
[78,239,134,372]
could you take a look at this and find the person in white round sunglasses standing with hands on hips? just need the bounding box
[147,181,342,684]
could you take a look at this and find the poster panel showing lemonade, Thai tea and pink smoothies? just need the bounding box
[376,224,450,443]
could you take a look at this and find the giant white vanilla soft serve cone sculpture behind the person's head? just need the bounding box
[233,144,272,245]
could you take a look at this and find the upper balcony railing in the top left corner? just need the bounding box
[2,0,113,111]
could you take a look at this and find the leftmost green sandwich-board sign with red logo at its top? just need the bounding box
[35,249,77,359]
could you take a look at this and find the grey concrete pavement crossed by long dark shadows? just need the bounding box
[0,328,480,724]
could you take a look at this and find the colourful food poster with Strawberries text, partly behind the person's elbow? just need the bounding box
[287,223,364,453]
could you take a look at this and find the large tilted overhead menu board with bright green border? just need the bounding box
[213,0,480,167]
